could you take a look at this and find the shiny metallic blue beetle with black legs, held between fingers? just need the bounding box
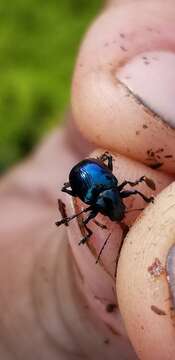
[56,152,155,244]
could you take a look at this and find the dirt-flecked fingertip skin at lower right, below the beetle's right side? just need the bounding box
[117,183,175,360]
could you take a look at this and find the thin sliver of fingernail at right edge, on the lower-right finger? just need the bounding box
[166,244,175,309]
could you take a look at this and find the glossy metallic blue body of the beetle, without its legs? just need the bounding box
[69,159,125,221]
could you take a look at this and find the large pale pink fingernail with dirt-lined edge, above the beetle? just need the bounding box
[116,51,175,128]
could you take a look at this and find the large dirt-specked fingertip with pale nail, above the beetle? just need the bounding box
[72,0,175,172]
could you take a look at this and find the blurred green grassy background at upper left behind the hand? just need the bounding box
[0,0,102,173]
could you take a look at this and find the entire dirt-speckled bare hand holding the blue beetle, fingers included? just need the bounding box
[0,0,175,360]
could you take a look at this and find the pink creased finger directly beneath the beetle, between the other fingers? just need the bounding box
[62,148,172,334]
